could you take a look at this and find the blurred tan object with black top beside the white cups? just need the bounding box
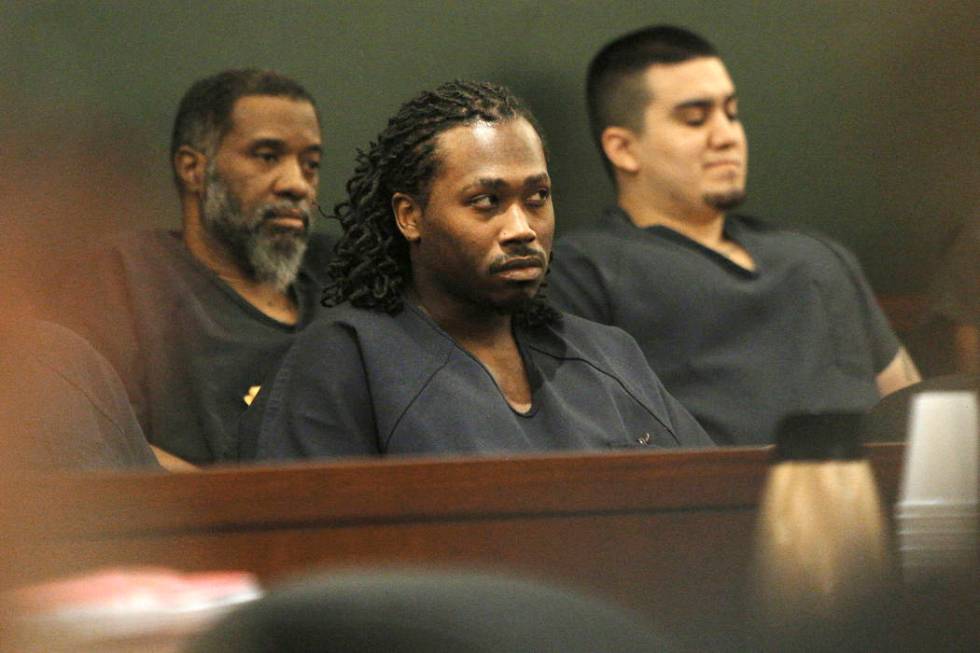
[751,414,893,651]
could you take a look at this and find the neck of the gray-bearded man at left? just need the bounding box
[183,221,299,324]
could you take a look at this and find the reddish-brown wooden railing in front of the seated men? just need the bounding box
[0,445,902,650]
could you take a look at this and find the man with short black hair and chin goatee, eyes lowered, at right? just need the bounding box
[550,26,919,445]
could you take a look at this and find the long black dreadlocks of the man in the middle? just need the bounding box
[323,80,560,327]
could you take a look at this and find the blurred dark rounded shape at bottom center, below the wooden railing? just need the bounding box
[190,570,673,653]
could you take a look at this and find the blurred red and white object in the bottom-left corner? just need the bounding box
[0,567,261,653]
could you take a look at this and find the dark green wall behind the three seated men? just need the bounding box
[0,0,980,292]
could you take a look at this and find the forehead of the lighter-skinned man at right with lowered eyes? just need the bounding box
[644,57,735,108]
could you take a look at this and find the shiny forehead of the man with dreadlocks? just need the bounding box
[435,118,548,183]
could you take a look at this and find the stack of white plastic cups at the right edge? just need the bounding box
[895,392,980,583]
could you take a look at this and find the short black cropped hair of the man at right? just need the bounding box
[585,25,718,174]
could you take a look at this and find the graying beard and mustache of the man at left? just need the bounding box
[201,166,310,292]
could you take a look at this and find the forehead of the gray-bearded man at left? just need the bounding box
[225,95,320,144]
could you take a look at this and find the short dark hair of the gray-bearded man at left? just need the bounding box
[170,68,320,188]
